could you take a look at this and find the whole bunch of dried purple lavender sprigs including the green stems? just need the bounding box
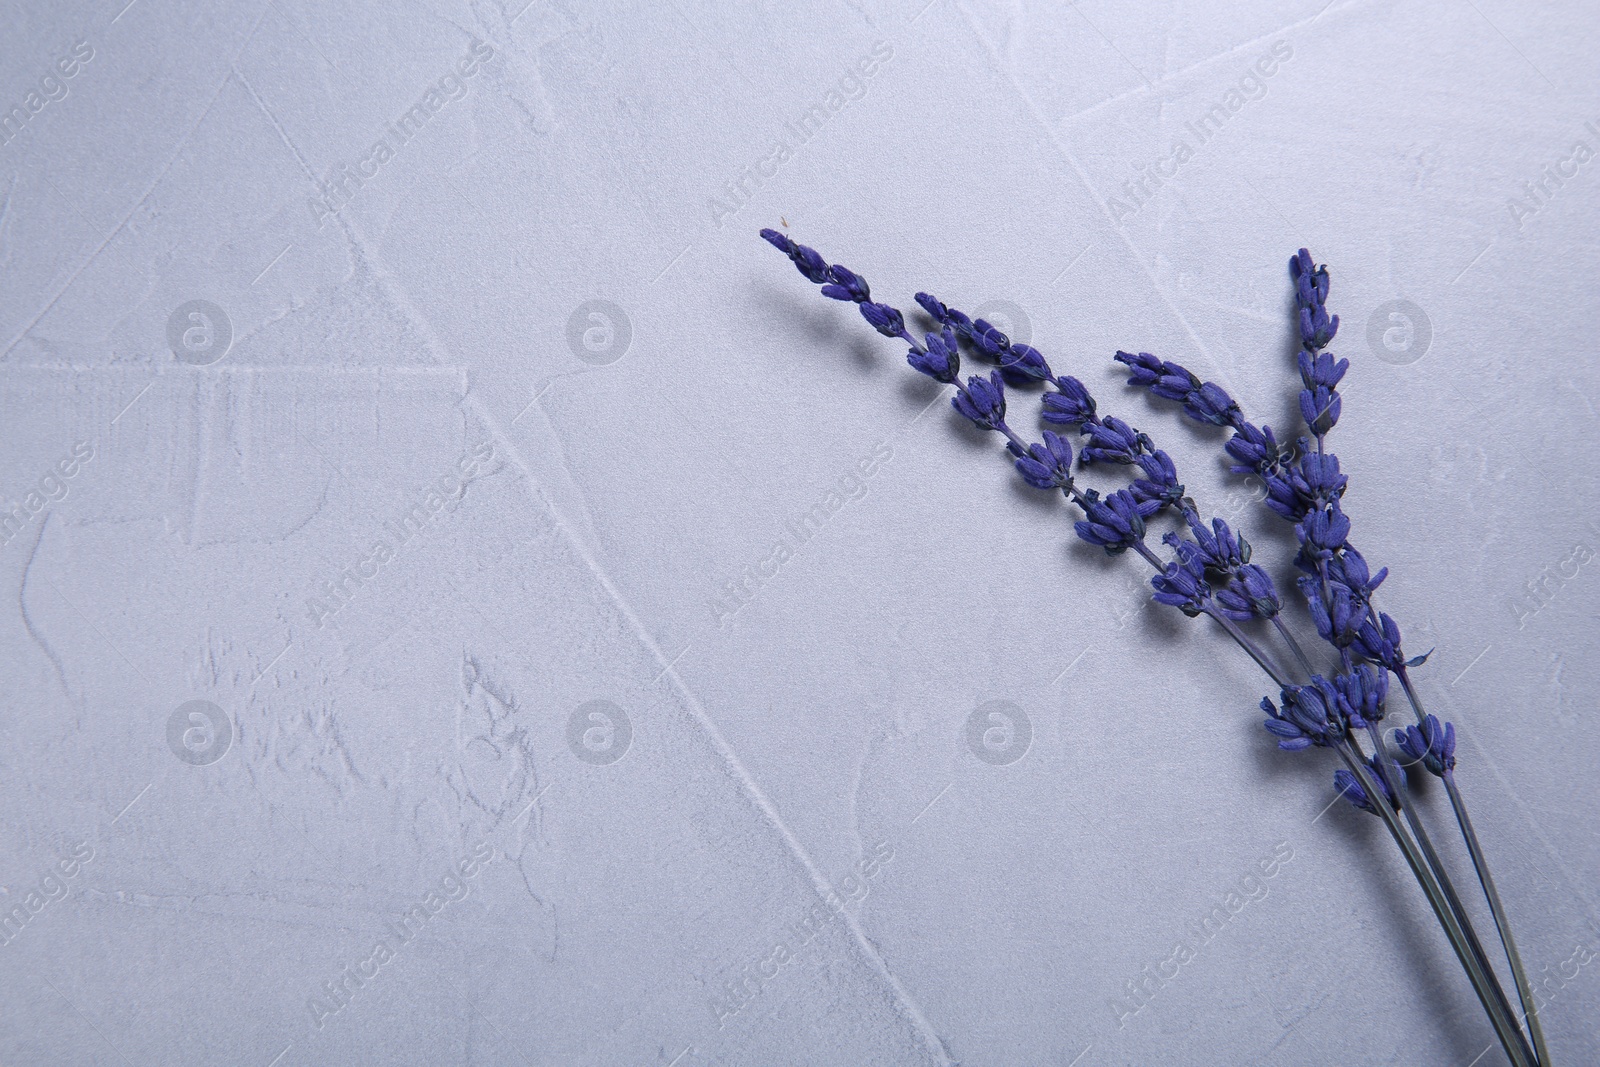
[762,229,1550,1067]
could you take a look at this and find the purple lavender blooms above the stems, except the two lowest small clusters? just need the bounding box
[762,230,1427,783]
